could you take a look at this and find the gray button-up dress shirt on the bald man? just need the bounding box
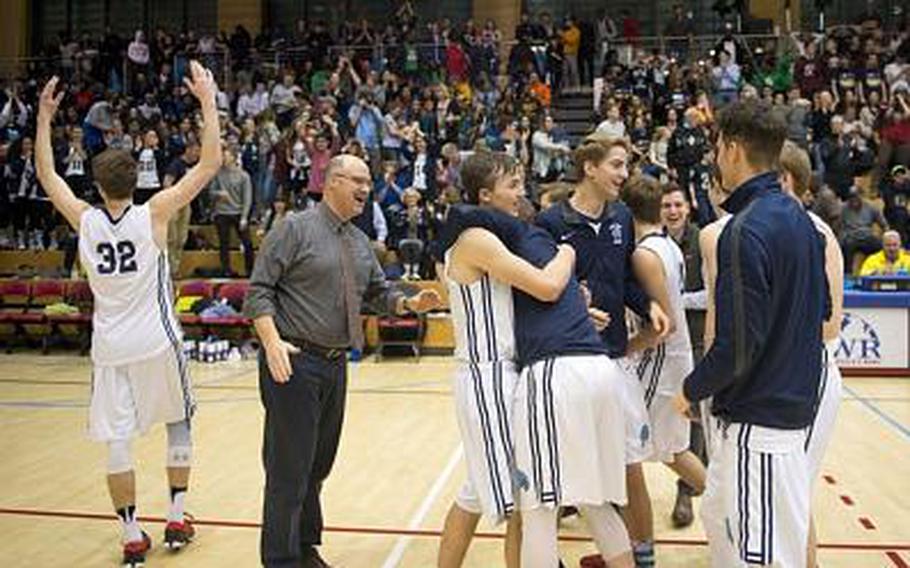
[244,203,402,348]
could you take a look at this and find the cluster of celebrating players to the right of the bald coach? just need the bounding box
[439,102,843,568]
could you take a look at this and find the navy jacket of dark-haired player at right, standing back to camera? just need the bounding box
[683,173,830,429]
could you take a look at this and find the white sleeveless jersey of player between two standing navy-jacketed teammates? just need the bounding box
[638,233,693,393]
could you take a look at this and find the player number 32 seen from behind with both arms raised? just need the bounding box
[37,62,221,567]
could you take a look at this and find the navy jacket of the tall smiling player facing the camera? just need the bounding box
[537,202,650,357]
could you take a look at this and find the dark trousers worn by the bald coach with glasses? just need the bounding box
[259,352,347,568]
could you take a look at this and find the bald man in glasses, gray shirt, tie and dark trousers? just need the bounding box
[245,155,439,568]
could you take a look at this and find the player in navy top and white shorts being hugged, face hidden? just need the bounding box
[440,173,634,568]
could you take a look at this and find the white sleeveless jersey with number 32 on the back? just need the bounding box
[79,204,183,366]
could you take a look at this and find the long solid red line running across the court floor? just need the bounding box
[0,507,910,552]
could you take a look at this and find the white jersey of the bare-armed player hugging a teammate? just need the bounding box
[446,252,515,363]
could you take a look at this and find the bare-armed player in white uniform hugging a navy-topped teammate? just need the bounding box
[438,152,575,568]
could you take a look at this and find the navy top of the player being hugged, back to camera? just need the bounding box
[442,206,605,367]
